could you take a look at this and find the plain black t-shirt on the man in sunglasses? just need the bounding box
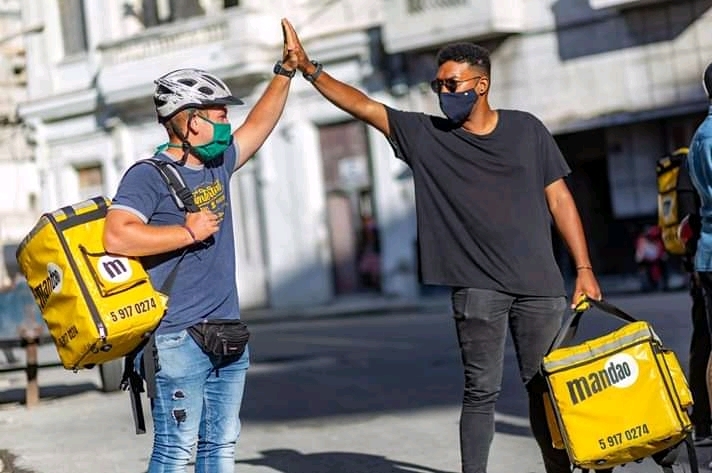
[388,108,570,296]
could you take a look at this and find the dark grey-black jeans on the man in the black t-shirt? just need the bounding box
[452,288,571,473]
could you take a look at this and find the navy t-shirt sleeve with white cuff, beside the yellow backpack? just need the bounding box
[110,164,165,223]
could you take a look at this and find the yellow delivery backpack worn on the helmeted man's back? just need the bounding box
[16,197,167,370]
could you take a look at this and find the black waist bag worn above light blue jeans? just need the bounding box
[188,319,250,357]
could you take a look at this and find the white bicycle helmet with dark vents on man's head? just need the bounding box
[153,69,244,123]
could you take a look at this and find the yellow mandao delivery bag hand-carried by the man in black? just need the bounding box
[542,300,697,472]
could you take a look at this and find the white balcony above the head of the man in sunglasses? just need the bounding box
[383,0,525,53]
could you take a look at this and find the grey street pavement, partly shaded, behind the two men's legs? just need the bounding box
[0,291,712,473]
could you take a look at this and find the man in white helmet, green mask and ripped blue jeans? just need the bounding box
[104,27,297,473]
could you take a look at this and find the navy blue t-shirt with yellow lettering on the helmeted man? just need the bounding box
[110,144,240,333]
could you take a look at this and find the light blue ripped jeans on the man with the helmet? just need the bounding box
[143,330,250,473]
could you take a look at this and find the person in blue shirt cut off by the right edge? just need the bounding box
[687,63,712,467]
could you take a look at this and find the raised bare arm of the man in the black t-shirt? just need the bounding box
[282,18,390,136]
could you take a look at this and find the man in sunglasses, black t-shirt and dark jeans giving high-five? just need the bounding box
[283,20,601,473]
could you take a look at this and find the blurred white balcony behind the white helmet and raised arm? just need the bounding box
[92,11,281,103]
